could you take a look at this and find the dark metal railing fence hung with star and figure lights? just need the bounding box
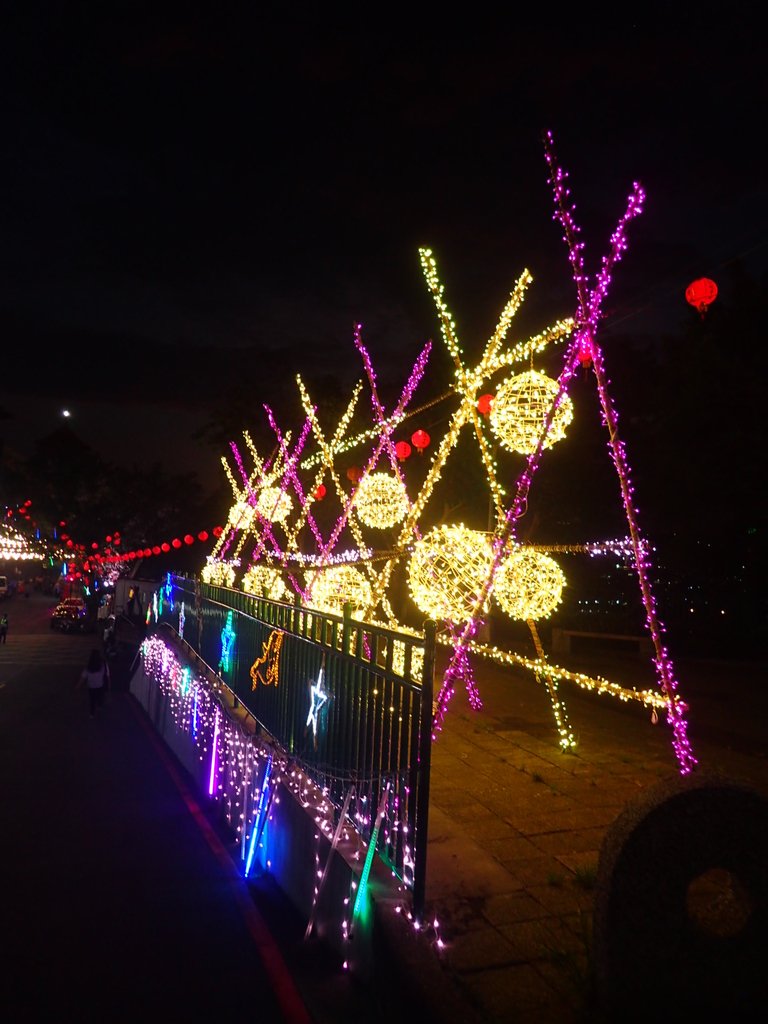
[155,574,435,916]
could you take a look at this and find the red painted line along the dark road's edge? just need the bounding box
[129,694,312,1024]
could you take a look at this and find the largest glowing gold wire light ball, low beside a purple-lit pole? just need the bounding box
[408,525,494,623]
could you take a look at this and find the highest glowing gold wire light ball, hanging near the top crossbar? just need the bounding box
[488,370,573,455]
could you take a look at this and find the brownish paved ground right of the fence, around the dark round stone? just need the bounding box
[417,657,768,1024]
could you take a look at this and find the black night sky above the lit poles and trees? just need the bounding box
[0,8,768,495]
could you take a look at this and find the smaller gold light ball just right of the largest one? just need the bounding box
[494,548,565,622]
